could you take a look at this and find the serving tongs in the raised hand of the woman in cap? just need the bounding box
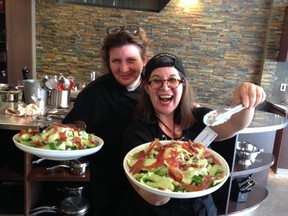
[203,103,245,126]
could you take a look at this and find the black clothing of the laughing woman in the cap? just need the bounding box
[118,107,217,216]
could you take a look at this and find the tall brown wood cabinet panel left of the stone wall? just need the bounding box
[4,0,36,85]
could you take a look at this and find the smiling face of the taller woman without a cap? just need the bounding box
[109,44,145,87]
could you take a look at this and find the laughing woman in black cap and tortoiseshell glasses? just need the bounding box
[118,53,266,216]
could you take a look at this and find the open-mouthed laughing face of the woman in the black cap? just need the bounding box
[145,67,183,115]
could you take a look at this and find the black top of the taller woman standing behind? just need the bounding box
[63,73,141,215]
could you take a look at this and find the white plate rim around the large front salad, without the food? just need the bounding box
[123,141,230,199]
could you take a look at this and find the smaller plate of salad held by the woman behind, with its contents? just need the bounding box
[13,124,104,160]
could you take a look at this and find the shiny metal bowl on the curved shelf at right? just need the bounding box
[236,142,263,165]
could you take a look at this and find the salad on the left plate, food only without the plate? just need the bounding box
[17,124,100,151]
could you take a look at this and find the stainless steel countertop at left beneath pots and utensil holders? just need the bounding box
[0,101,69,130]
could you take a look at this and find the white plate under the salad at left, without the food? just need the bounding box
[13,134,104,161]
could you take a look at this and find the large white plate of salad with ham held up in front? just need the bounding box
[123,139,229,198]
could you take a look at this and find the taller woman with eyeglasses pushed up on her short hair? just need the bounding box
[63,26,152,216]
